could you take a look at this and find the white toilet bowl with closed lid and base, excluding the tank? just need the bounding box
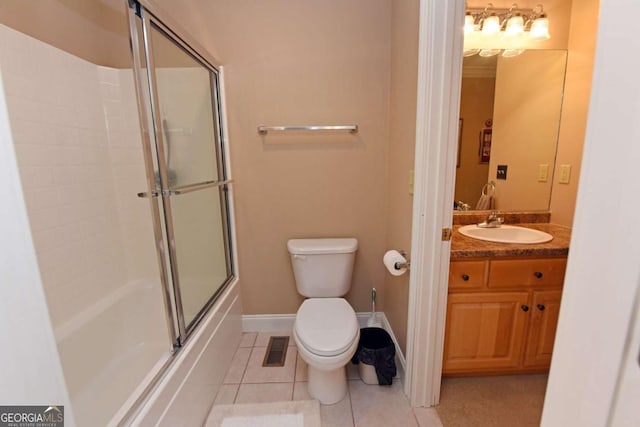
[293,298,360,405]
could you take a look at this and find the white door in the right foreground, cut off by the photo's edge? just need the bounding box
[541,0,640,427]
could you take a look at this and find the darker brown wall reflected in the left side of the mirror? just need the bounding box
[454,76,496,209]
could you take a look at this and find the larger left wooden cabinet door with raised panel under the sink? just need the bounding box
[443,292,531,374]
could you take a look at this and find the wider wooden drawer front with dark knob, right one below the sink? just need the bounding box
[488,258,567,289]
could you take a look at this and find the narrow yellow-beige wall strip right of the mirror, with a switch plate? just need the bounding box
[550,0,599,226]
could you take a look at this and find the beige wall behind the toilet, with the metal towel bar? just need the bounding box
[157,0,391,314]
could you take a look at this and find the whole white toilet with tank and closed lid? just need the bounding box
[287,238,360,405]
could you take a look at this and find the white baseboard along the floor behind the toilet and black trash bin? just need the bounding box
[242,312,407,378]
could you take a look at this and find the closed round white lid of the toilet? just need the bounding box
[295,298,359,356]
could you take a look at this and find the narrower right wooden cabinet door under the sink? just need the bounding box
[524,291,562,368]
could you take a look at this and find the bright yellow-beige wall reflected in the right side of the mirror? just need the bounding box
[489,50,566,210]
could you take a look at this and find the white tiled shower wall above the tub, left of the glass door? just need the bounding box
[0,21,159,328]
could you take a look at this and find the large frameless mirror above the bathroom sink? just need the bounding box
[454,50,567,211]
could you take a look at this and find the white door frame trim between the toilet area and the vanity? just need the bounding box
[405,0,465,406]
